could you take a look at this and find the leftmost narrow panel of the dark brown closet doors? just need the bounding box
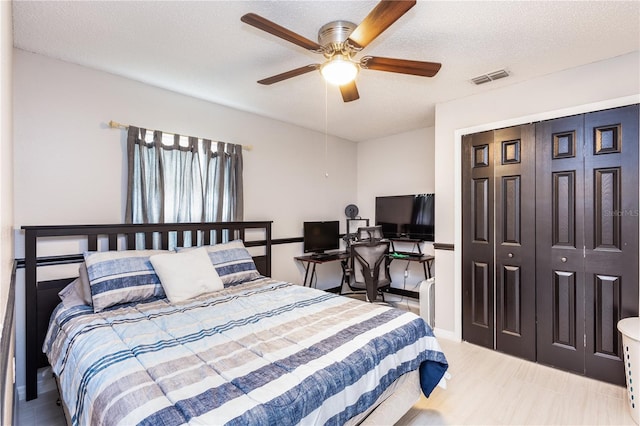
[462,131,494,349]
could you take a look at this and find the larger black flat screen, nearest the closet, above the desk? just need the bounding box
[376,194,435,241]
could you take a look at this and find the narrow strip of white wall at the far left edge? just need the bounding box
[0,1,14,423]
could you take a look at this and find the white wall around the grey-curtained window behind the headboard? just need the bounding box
[13,50,356,396]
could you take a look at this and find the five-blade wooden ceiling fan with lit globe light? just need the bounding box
[240,0,441,102]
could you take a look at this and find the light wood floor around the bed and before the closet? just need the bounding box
[16,299,635,426]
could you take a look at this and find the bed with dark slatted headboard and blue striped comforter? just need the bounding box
[24,222,447,425]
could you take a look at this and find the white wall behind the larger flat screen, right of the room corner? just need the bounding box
[356,127,438,291]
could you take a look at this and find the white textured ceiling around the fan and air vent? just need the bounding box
[13,1,640,141]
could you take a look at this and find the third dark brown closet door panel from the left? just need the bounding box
[536,116,584,374]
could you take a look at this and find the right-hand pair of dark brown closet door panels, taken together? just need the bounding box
[536,105,638,385]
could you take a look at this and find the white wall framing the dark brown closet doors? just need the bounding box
[435,52,640,338]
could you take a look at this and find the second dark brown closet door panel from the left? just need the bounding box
[493,125,536,361]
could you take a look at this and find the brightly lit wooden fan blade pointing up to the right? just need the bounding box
[347,0,416,48]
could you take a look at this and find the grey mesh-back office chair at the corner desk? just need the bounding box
[348,241,391,303]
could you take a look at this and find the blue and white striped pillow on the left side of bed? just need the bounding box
[84,250,168,313]
